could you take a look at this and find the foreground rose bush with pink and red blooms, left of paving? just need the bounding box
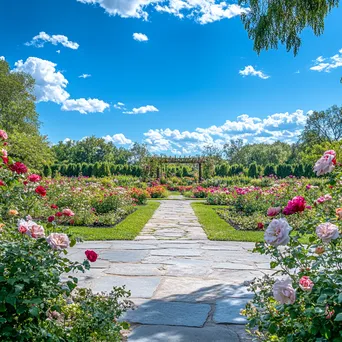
[0,130,131,342]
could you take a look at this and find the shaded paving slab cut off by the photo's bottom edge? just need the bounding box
[128,325,240,342]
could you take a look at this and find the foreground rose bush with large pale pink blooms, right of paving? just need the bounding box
[242,151,342,342]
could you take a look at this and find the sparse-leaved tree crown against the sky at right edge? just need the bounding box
[301,105,342,145]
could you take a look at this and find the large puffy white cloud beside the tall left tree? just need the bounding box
[13,57,70,103]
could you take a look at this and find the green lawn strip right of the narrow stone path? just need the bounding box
[191,203,264,242]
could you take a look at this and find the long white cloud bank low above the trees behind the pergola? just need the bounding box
[144,110,310,154]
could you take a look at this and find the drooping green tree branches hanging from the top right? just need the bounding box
[239,0,339,55]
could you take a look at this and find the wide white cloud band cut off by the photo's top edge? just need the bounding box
[77,0,248,24]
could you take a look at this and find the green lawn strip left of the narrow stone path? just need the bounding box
[70,202,160,241]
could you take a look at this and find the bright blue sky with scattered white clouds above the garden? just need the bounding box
[0,0,342,154]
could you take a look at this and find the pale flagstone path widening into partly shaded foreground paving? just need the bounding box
[70,201,270,342]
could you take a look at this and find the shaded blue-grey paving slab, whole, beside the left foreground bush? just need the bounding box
[123,300,211,327]
